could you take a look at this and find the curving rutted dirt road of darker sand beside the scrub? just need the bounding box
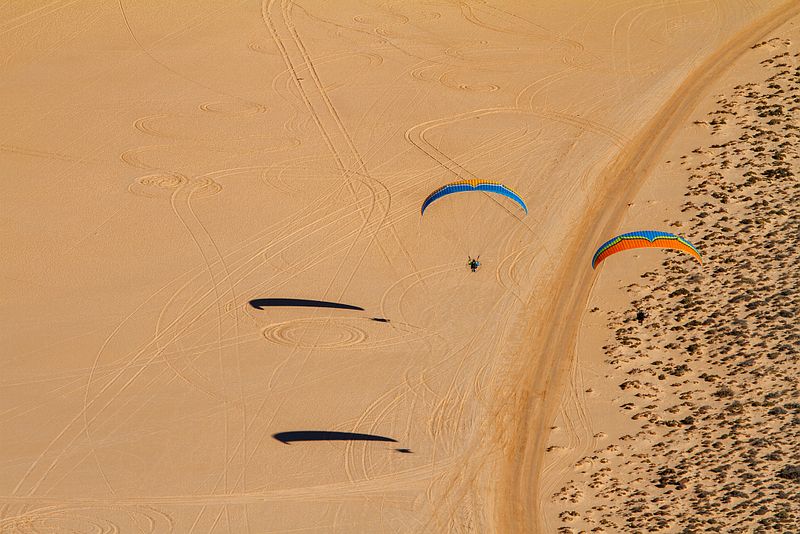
[495,0,800,532]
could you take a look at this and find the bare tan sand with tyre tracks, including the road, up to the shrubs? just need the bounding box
[0,0,800,533]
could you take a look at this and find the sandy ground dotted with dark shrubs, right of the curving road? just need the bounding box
[542,24,800,532]
